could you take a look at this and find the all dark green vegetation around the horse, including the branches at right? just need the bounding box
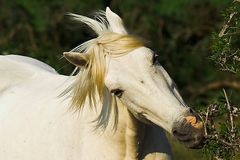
[0,0,240,160]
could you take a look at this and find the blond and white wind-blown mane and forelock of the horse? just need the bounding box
[65,11,143,128]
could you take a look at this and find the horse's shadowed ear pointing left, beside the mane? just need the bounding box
[63,52,88,67]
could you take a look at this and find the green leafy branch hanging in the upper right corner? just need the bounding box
[211,0,240,74]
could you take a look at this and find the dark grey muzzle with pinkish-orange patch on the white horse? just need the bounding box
[172,113,204,148]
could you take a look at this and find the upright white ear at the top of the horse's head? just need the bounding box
[106,7,127,34]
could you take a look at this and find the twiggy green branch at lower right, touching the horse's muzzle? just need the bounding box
[201,89,240,159]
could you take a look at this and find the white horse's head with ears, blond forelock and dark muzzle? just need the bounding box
[64,8,203,148]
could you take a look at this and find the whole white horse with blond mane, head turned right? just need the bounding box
[0,8,203,160]
